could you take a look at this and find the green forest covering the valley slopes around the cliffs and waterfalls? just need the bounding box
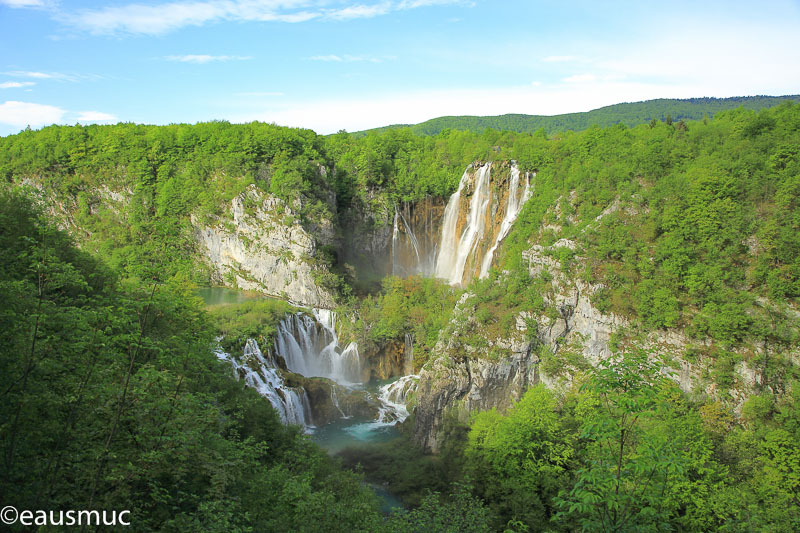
[0,102,800,531]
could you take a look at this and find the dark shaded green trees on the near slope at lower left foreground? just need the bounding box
[0,192,381,532]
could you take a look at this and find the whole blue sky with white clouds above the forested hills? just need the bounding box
[0,0,800,135]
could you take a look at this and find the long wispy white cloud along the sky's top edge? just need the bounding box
[61,0,463,35]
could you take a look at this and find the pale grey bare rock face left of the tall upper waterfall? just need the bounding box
[192,186,334,308]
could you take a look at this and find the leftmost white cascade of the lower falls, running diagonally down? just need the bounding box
[215,339,311,427]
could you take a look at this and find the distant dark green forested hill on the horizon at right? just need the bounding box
[356,94,800,136]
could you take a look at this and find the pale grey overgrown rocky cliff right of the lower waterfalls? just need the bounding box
[413,233,776,452]
